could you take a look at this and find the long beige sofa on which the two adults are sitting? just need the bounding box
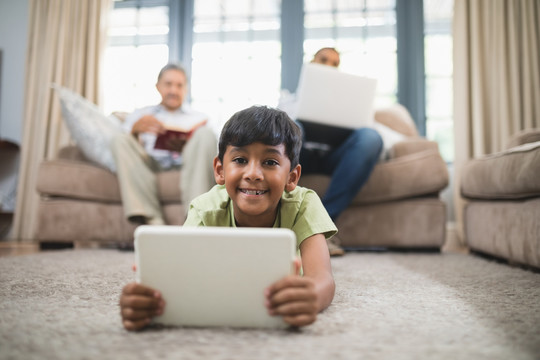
[35,105,448,248]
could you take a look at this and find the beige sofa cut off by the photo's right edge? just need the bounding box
[460,129,540,268]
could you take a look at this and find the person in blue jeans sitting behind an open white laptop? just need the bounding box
[278,47,383,256]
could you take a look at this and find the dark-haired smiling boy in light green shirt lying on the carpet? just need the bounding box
[120,106,337,330]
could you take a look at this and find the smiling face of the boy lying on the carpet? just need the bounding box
[214,142,301,227]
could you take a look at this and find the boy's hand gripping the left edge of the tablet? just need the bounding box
[120,282,165,331]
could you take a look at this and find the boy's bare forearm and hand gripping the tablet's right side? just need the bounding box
[266,234,335,326]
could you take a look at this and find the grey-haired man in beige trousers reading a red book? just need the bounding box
[111,64,217,225]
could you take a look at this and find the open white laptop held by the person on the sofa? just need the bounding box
[296,63,377,147]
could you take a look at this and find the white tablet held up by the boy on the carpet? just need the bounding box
[135,225,296,328]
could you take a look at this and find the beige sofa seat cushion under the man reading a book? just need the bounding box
[37,159,184,203]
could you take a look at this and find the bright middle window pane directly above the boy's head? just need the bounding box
[191,0,281,129]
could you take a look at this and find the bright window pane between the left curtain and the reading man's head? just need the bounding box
[102,1,169,114]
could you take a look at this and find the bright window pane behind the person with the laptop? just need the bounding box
[304,0,397,106]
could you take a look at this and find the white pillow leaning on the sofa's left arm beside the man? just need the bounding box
[52,84,122,172]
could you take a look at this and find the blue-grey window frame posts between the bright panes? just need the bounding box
[114,0,427,136]
